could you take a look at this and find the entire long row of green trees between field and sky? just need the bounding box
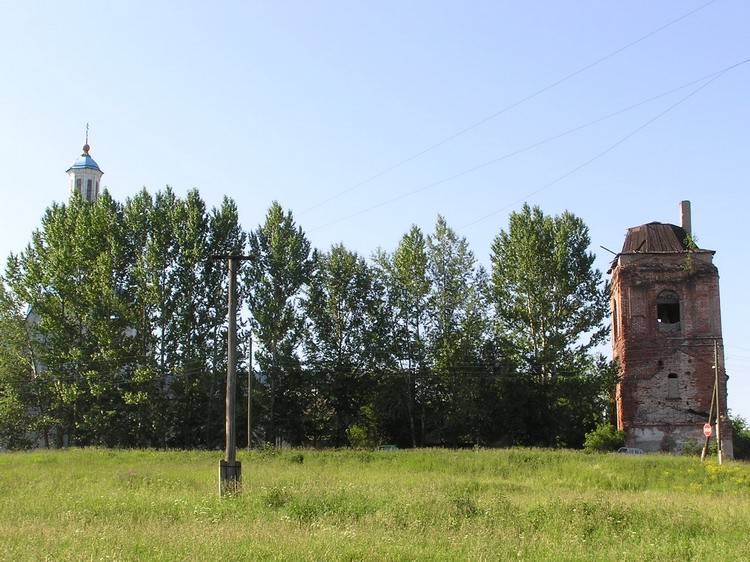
[0,188,617,448]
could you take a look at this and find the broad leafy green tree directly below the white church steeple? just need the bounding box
[7,190,132,445]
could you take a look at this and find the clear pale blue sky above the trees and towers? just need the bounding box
[0,0,750,420]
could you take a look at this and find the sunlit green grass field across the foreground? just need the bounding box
[0,449,750,561]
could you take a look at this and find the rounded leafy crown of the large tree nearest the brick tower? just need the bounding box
[490,201,608,380]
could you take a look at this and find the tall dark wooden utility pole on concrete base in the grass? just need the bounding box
[211,255,249,496]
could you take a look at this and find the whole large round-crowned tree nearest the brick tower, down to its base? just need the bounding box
[489,205,608,446]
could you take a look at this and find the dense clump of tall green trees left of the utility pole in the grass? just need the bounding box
[3,188,244,446]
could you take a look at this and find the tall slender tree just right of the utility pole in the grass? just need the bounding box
[245,202,312,443]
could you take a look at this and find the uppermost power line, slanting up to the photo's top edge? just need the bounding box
[299,0,717,215]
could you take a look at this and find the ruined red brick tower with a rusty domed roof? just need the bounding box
[610,201,732,458]
